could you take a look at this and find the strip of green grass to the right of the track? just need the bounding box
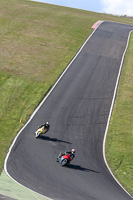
[106,33,133,195]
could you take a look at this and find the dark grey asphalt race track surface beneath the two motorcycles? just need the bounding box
[7,22,133,200]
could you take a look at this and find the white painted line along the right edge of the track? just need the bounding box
[103,31,133,198]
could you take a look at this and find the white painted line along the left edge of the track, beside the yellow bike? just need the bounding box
[4,21,104,198]
